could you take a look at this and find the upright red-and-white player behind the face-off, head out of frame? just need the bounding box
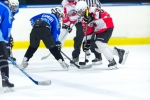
[60,0,91,66]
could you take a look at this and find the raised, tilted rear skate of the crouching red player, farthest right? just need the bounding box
[115,47,129,65]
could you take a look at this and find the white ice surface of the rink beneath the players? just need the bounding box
[0,45,150,100]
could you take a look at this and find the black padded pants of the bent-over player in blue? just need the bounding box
[30,21,55,49]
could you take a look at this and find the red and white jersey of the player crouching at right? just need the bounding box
[83,7,114,34]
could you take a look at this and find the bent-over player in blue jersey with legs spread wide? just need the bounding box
[21,7,69,70]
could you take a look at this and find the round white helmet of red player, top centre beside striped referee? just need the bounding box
[75,1,88,12]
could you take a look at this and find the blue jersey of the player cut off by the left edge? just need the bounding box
[0,2,12,43]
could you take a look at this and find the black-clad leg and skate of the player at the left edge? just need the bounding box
[0,42,14,92]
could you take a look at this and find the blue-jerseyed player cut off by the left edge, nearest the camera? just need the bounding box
[0,0,14,92]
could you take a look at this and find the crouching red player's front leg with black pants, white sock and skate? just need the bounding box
[95,29,117,69]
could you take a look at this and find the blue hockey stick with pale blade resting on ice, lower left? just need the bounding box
[8,57,51,86]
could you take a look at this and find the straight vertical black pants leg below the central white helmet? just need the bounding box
[72,22,84,58]
